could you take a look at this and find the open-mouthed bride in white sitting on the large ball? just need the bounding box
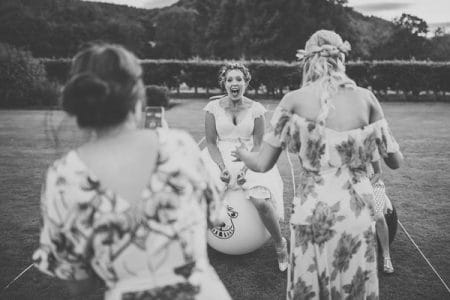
[202,63,288,271]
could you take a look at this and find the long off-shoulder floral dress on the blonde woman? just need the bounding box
[265,99,399,299]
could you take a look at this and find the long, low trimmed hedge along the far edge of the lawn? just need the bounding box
[42,59,450,96]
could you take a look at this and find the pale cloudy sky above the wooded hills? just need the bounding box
[84,0,450,33]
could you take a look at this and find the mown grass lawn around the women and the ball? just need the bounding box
[0,99,450,300]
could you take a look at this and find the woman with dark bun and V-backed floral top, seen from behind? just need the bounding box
[33,45,230,300]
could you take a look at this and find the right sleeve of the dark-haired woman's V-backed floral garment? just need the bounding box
[159,129,228,226]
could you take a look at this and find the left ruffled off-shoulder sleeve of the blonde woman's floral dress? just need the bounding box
[264,106,301,152]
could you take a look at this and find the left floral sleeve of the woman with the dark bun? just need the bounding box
[33,165,93,280]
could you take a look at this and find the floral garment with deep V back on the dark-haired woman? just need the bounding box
[33,129,230,300]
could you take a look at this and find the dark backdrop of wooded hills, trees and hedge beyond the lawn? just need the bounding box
[0,0,450,108]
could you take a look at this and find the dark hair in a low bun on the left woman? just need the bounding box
[62,44,145,128]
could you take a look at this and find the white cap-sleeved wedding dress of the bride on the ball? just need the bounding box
[202,99,284,219]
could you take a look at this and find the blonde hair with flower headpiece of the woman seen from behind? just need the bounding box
[297,30,356,101]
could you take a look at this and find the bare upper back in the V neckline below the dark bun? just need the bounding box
[77,130,158,204]
